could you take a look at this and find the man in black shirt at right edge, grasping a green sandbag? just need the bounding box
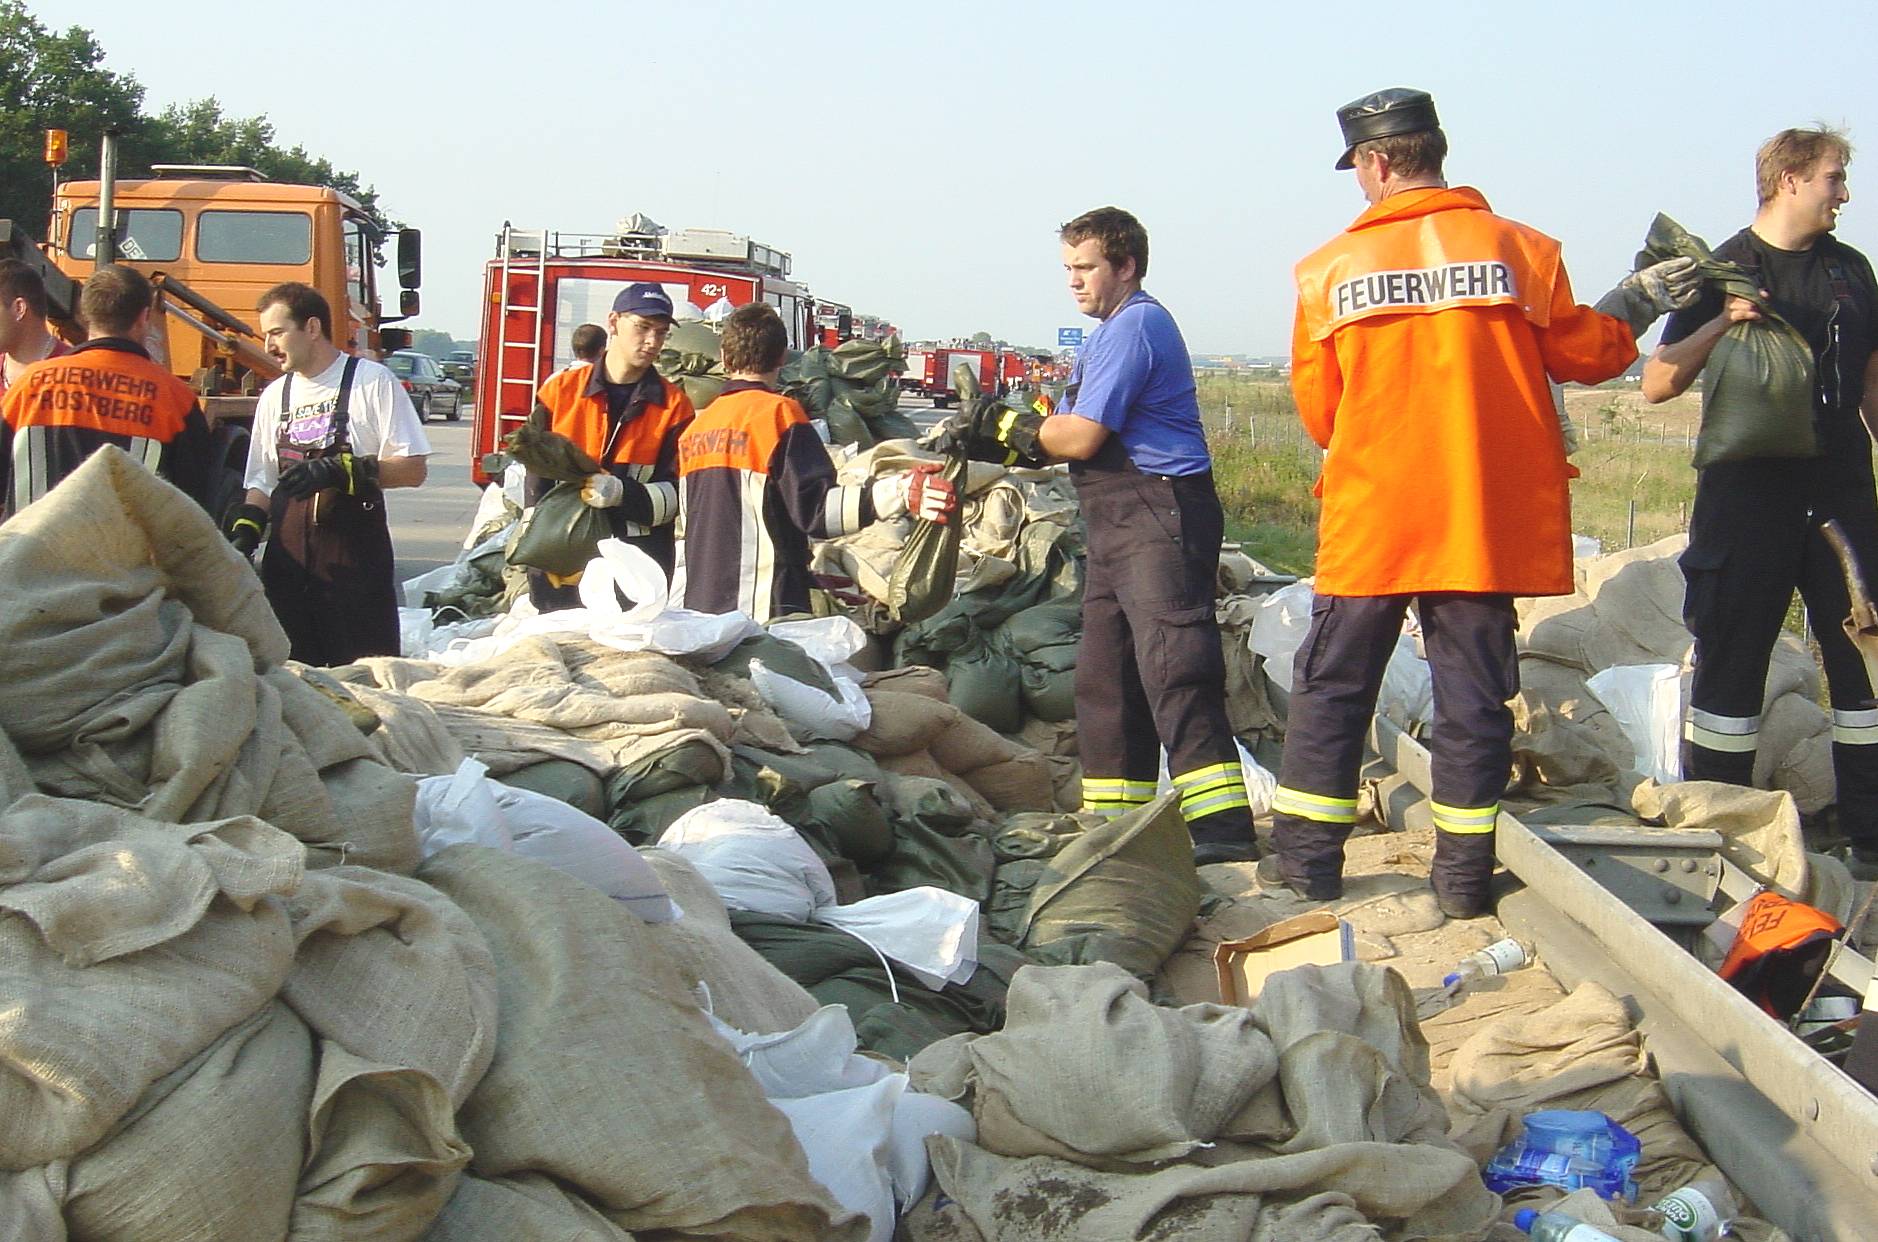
[1643,130,1878,879]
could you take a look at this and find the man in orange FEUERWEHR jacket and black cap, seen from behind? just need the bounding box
[1260,88,1700,919]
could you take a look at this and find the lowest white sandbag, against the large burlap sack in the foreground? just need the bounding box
[770,1075,907,1242]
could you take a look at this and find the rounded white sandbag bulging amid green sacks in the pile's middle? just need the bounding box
[659,799,836,923]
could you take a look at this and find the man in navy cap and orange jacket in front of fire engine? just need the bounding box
[524,282,693,613]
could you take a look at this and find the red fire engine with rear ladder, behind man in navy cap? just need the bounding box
[470,220,815,485]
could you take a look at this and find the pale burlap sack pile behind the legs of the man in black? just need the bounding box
[1514,536,1833,814]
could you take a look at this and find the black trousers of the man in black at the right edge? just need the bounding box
[1681,458,1878,853]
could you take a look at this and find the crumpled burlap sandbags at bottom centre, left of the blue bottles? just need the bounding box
[901,962,1499,1242]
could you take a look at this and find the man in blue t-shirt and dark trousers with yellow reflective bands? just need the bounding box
[975,207,1258,864]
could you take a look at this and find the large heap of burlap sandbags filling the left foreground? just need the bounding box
[0,449,868,1242]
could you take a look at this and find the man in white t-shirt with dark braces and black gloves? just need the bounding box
[227,282,430,665]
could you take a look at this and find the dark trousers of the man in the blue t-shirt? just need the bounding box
[1070,436,1253,844]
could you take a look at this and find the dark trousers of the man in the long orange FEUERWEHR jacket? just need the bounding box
[1271,592,1519,906]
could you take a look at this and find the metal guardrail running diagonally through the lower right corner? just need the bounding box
[1371,716,1878,1242]
